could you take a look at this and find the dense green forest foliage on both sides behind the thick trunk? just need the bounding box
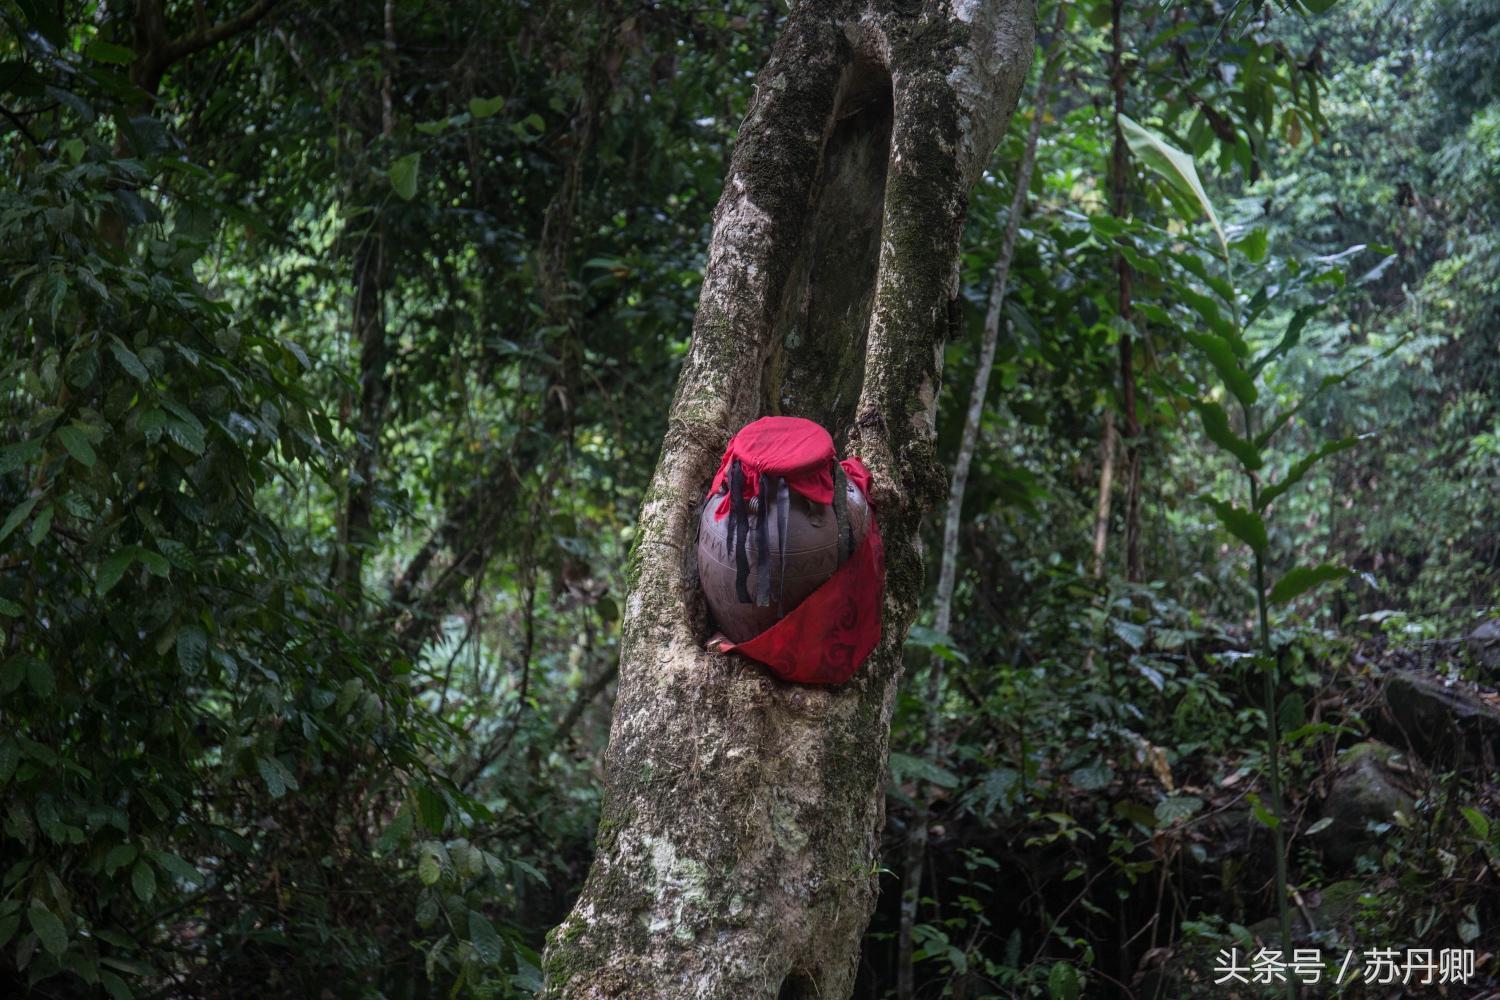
[0,0,1500,1000]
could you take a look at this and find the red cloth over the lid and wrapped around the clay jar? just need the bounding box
[708,417,885,684]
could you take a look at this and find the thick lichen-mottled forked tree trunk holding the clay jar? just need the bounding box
[543,0,1035,1000]
